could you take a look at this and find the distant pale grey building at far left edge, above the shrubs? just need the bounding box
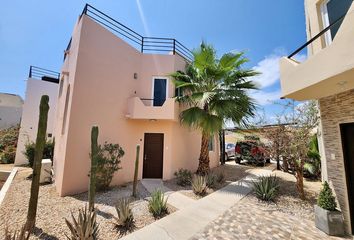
[0,93,23,129]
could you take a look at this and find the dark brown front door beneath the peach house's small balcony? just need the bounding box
[143,133,163,178]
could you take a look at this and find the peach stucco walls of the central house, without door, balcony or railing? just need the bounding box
[54,16,219,196]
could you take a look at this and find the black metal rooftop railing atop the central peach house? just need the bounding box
[64,4,193,62]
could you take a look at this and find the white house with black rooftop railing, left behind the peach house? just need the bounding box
[15,66,59,165]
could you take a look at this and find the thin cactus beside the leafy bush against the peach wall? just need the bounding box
[89,126,98,211]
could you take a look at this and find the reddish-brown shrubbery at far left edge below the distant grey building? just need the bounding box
[0,126,19,163]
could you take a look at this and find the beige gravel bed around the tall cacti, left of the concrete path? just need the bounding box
[0,169,176,239]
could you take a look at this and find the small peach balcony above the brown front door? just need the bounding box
[126,97,179,121]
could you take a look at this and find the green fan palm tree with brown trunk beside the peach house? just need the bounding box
[171,43,258,175]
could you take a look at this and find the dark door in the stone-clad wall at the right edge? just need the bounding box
[340,123,354,232]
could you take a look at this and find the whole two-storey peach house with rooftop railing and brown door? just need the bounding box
[54,5,219,196]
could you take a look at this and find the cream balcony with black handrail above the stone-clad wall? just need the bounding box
[280,6,354,100]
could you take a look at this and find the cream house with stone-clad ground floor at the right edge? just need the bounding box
[280,0,354,233]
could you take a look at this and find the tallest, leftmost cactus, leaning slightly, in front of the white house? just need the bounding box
[26,95,49,231]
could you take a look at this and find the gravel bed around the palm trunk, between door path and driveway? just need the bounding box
[164,161,252,200]
